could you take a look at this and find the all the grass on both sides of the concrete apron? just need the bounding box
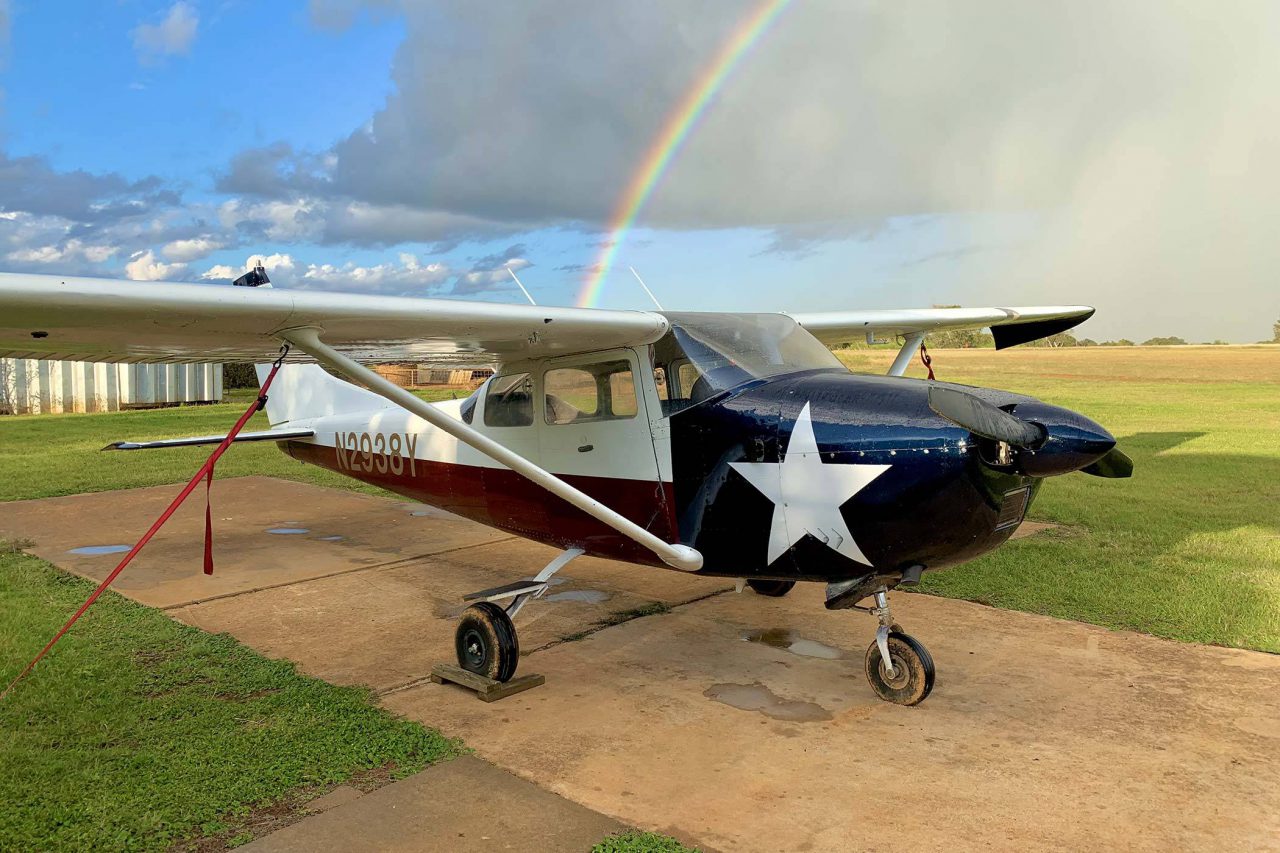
[0,347,1280,850]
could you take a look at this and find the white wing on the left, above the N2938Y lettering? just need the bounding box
[0,273,668,365]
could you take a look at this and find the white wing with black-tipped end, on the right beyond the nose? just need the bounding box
[791,305,1093,350]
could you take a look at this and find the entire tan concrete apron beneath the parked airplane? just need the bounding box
[0,478,1280,850]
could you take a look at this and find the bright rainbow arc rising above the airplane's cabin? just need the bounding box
[577,0,791,307]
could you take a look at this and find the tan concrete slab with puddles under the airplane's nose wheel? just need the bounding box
[384,585,1280,850]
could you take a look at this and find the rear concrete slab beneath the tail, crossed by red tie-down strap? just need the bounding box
[0,473,509,607]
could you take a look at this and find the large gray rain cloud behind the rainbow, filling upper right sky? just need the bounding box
[249,0,1280,338]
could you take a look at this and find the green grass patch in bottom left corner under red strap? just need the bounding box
[0,540,460,850]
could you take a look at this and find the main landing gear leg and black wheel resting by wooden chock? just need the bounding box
[453,548,584,681]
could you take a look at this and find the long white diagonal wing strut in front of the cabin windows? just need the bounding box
[278,327,703,571]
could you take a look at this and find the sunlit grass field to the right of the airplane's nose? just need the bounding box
[829,348,1280,652]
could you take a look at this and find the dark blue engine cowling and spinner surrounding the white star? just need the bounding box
[671,370,1100,581]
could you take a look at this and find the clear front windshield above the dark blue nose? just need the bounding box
[654,311,845,402]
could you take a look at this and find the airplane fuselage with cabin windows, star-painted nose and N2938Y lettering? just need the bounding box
[268,308,1115,587]
